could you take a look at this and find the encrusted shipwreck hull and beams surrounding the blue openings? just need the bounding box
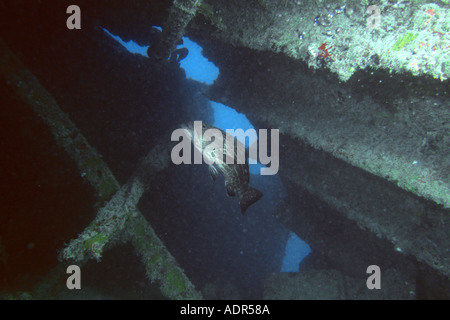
[0,0,450,299]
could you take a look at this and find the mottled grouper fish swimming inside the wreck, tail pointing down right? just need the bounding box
[182,121,263,214]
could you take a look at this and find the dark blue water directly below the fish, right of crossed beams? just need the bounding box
[139,160,288,299]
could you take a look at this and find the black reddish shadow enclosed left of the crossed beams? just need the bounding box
[0,77,95,291]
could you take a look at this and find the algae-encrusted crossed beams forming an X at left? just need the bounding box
[0,39,202,299]
